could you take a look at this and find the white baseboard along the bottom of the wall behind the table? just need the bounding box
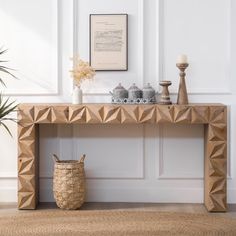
[0,187,236,204]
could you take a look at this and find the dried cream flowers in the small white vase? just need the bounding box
[70,57,96,87]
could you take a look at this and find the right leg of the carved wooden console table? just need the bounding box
[204,107,227,212]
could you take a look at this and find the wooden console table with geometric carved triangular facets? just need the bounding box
[18,104,227,212]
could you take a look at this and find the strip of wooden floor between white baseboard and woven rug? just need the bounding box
[0,202,236,218]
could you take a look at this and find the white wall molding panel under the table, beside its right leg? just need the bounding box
[157,125,204,180]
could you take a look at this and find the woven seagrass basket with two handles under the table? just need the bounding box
[53,154,85,210]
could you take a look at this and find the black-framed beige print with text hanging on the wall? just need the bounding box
[90,14,128,71]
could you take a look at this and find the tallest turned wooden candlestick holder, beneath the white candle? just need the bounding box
[176,63,188,105]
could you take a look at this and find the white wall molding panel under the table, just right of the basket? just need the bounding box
[73,125,145,180]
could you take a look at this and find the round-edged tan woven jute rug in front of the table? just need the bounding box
[0,209,236,236]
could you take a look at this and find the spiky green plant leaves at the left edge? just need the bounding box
[0,48,17,136]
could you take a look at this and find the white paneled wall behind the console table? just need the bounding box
[0,0,236,203]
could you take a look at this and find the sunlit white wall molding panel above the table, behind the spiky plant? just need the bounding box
[0,0,61,97]
